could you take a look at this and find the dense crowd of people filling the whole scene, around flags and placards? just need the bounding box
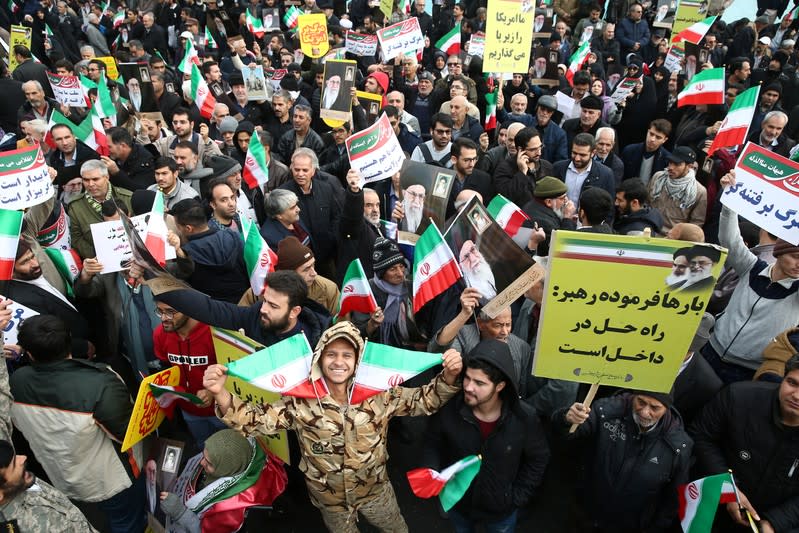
[0,0,799,533]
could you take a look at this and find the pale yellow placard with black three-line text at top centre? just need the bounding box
[483,0,533,72]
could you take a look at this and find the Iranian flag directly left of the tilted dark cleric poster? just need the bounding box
[413,224,463,313]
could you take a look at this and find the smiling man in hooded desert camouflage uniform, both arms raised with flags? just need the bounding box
[203,322,462,533]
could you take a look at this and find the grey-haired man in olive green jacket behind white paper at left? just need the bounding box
[67,160,133,259]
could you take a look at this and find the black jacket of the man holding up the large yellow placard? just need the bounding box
[552,392,692,532]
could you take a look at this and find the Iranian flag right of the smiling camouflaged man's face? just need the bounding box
[350,342,442,405]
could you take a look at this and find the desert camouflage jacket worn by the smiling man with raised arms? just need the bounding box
[217,374,460,512]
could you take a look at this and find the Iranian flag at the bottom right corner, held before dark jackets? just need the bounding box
[678,472,736,533]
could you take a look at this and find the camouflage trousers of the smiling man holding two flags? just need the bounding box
[320,481,408,533]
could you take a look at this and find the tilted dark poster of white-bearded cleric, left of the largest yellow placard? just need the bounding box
[444,198,543,317]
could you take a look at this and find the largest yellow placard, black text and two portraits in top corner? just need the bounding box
[533,231,727,392]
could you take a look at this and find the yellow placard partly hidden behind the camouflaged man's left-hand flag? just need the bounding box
[211,328,289,463]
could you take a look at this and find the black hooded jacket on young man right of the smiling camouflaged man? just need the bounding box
[424,340,550,521]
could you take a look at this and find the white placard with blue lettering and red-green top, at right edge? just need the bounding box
[721,142,799,245]
